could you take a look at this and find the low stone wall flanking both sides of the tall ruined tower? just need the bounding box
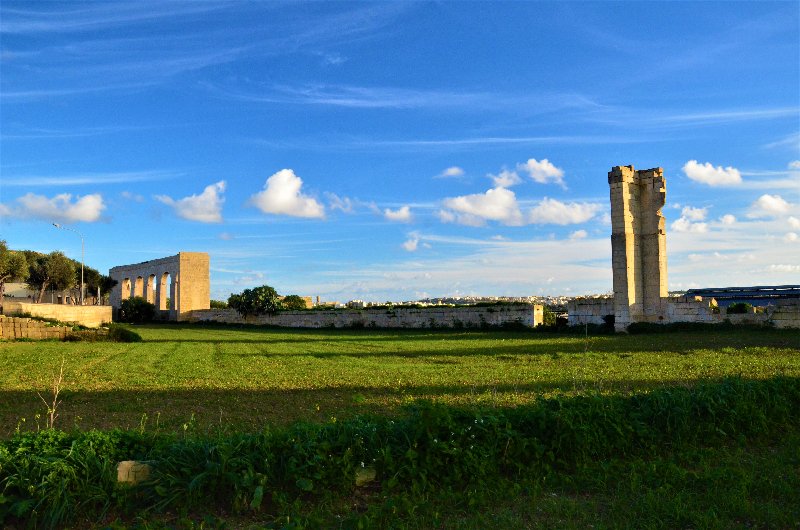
[567,296,800,329]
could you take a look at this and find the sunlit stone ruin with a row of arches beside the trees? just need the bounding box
[109,252,211,320]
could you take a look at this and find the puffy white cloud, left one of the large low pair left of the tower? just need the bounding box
[440,187,522,226]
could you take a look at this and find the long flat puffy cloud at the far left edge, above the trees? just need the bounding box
[0,193,106,223]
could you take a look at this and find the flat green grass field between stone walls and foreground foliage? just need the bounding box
[0,325,800,437]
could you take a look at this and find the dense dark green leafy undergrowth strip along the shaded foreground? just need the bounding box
[0,377,800,527]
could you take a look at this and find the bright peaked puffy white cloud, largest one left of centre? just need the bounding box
[250,169,325,219]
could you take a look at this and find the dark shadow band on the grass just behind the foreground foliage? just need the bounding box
[0,378,768,437]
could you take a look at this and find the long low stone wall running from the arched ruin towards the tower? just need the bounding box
[189,304,543,329]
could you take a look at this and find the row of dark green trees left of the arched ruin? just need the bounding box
[0,240,117,305]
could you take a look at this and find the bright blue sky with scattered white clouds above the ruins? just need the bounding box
[0,0,800,301]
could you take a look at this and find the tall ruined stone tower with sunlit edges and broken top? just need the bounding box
[608,166,668,331]
